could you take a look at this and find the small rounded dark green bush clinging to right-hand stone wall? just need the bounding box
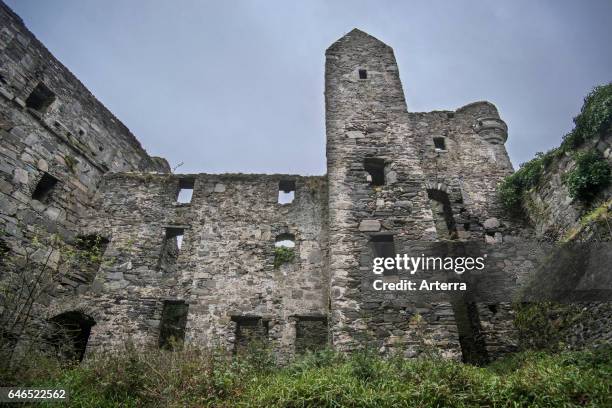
[563,149,610,201]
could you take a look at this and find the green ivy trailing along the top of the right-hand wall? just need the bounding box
[498,83,612,214]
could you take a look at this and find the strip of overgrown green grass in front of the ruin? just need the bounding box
[1,348,612,407]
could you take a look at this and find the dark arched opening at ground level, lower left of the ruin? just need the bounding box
[47,311,96,361]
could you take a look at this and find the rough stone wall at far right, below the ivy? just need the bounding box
[523,133,612,348]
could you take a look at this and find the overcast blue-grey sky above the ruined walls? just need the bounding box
[5,0,612,174]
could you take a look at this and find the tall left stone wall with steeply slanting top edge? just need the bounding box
[0,2,169,356]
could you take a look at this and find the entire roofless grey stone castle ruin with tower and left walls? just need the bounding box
[0,4,608,361]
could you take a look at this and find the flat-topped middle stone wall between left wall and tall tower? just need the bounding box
[74,173,328,356]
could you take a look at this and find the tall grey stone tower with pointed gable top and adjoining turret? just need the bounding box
[325,29,512,357]
